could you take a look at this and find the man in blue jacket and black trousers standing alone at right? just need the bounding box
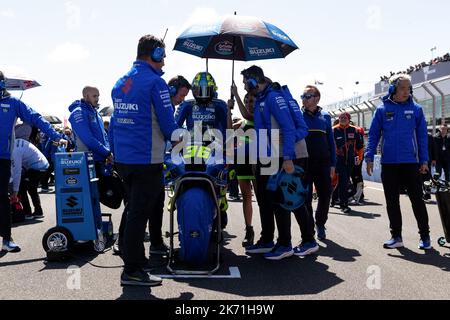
[365,74,431,250]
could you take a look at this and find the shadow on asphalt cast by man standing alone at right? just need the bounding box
[389,248,450,271]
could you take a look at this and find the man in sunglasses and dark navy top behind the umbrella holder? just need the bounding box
[302,86,336,240]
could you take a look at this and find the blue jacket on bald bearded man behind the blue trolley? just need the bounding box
[69,100,110,161]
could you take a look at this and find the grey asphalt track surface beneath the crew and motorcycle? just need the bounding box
[0,182,450,300]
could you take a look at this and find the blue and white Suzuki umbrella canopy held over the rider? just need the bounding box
[174,15,298,61]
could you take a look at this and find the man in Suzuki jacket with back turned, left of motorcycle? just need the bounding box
[110,35,178,286]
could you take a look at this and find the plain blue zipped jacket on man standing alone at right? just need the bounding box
[365,96,428,164]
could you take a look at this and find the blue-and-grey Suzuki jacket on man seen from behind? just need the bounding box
[110,60,178,164]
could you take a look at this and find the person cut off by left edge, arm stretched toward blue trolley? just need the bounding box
[0,71,67,252]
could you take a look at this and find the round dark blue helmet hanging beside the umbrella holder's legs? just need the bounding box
[266,166,308,211]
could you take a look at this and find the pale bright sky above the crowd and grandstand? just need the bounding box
[0,0,450,118]
